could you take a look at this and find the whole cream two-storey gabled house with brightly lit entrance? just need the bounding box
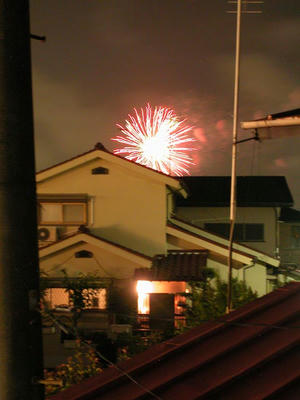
[36,144,282,362]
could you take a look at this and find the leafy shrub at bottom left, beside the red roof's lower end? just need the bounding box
[44,341,101,396]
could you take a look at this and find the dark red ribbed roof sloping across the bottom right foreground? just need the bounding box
[51,283,300,400]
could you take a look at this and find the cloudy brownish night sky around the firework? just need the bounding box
[30,0,300,208]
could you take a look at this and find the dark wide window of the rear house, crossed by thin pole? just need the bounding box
[204,223,264,242]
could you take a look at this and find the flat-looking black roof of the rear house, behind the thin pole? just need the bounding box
[176,176,293,207]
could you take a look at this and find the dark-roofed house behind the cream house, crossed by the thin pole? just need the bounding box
[174,176,293,257]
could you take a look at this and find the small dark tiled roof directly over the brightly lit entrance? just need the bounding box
[135,250,208,281]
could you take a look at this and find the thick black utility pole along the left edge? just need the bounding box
[0,0,44,400]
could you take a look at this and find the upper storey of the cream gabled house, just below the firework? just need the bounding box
[36,144,184,256]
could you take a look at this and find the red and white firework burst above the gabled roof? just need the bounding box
[112,104,195,176]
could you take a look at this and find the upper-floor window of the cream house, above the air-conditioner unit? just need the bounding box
[39,202,87,225]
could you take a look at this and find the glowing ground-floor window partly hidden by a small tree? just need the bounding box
[44,288,106,312]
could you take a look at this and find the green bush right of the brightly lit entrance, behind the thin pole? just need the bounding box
[186,273,257,327]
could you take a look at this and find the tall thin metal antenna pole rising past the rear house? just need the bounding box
[226,0,242,313]
